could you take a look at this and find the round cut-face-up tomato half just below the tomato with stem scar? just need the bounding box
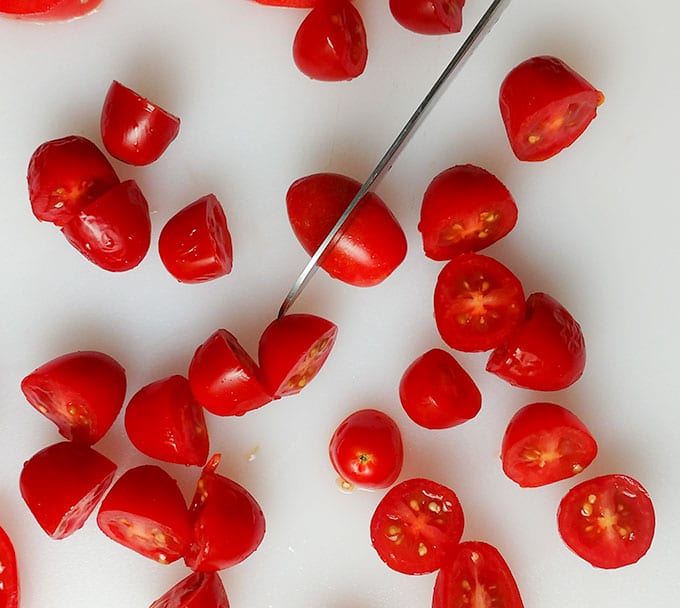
[371,479,464,574]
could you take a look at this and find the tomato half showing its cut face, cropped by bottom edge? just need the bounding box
[432,541,524,608]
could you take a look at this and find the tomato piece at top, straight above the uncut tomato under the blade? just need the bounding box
[293,0,368,81]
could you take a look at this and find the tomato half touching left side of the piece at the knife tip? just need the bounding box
[189,329,272,416]
